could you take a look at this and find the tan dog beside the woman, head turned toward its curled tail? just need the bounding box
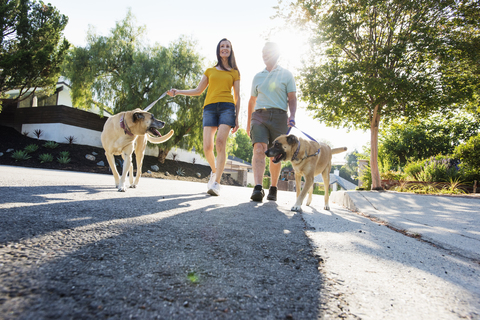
[101,109,173,192]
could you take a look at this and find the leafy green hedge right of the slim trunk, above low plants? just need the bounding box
[378,114,480,170]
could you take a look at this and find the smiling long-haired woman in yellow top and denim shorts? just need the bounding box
[168,39,240,196]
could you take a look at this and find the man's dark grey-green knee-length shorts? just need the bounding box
[250,109,288,148]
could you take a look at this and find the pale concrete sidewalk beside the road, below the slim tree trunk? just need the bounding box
[330,191,480,262]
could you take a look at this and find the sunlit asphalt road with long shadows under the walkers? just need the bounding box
[0,166,480,319]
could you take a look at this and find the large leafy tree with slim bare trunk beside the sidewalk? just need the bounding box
[279,0,480,189]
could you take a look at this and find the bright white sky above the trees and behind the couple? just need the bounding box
[44,0,370,163]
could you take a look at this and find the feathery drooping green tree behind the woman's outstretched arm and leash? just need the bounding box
[64,11,205,162]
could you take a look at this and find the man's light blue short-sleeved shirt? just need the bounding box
[252,66,297,111]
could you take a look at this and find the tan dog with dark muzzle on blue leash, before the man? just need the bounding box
[265,135,347,211]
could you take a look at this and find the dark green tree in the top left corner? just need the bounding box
[0,0,70,111]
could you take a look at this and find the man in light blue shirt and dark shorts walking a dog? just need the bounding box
[247,42,297,201]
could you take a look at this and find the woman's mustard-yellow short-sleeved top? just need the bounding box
[203,67,240,107]
